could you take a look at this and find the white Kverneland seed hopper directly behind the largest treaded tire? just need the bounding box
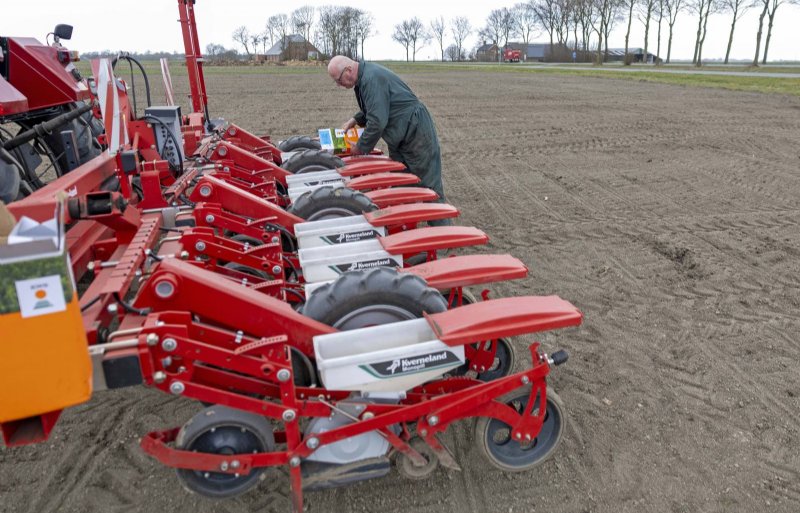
[297,239,403,283]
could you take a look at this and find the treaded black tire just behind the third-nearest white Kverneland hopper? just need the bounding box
[288,185,378,221]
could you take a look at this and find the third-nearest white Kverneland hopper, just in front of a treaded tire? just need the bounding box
[294,216,386,249]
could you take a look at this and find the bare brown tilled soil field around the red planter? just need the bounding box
[0,70,800,513]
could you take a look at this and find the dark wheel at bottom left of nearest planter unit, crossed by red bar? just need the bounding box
[176,406,275,499]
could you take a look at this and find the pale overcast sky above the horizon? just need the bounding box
[0,0,800,61]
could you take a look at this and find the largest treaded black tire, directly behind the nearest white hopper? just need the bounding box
[303,267,447,331]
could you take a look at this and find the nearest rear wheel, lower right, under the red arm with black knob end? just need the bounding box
[475,385,565,472]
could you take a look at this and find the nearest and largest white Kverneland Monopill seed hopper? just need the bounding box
[314,319,464,392]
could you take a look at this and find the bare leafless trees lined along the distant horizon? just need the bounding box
[209,0,800,66]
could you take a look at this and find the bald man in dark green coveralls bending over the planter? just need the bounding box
[328,55,452,226]
